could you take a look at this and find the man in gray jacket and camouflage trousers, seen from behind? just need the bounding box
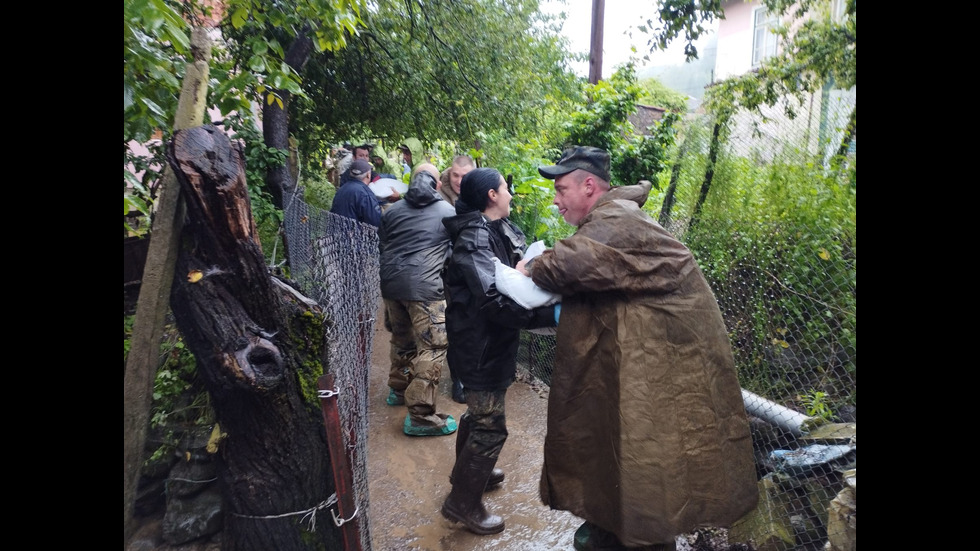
[378,163,456,436]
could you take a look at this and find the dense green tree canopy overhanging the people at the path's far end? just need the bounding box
[291,0,580,170]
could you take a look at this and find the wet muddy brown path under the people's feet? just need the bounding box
[367,310,582,551]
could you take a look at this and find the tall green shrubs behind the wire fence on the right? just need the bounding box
[675,127,857,411]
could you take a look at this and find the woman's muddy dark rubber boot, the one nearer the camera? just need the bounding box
[442,449,504,536]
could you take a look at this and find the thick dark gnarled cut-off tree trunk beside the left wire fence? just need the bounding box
[168,125,342,551]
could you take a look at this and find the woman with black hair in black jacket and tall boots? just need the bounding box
[442,168,556,534]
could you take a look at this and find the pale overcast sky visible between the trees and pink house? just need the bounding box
[540,0,717,79]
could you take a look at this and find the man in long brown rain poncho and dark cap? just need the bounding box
[517,147,758,550]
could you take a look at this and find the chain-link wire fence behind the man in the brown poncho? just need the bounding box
[518,90,857,549]
